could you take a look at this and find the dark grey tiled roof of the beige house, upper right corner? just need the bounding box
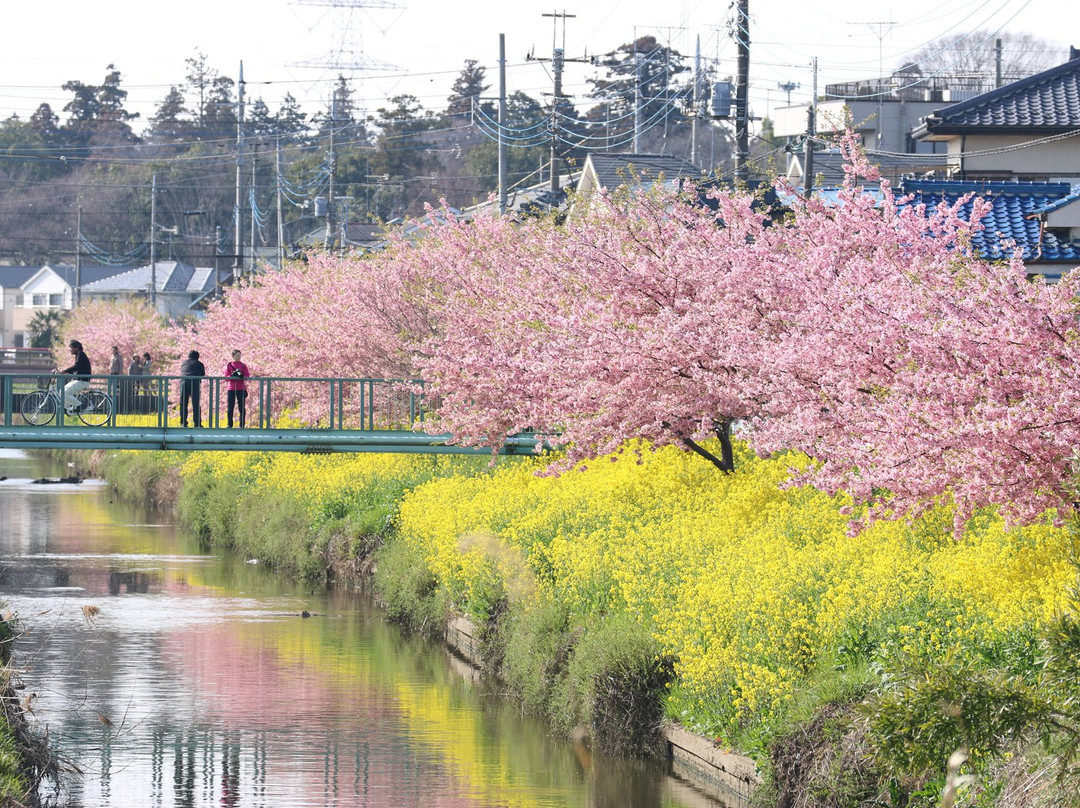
[913,58,1080,138]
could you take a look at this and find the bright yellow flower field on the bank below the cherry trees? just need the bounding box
[177,448,1076,733]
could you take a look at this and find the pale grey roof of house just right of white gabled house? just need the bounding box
[81,260,221,319]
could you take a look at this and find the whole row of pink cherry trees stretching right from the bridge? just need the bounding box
[191,131,1080,525]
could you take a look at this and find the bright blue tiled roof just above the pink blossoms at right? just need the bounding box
[901,179,1080,265]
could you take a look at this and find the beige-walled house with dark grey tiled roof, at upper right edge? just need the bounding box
[913,48,1080,183]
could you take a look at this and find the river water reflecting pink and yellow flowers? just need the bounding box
[0,449,723,808]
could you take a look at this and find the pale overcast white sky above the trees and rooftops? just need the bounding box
[0,0,1080,131]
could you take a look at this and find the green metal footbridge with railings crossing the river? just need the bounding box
[0,368,538,455]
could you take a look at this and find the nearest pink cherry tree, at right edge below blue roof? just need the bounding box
[751,156,1080,529]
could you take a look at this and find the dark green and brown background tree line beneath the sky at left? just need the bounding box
[0,36,730,266]
